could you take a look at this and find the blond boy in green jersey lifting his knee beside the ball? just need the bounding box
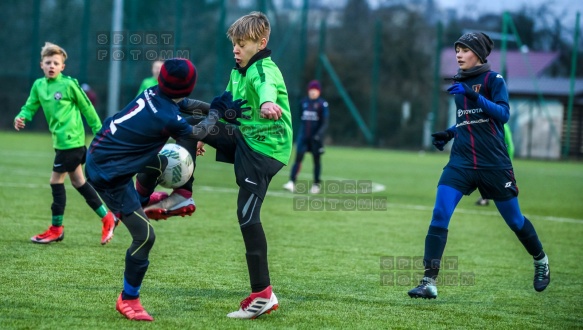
[146,12,292,319]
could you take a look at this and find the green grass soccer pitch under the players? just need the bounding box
[0,132,583,329]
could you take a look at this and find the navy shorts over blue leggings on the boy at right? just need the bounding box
[439,166,518,201]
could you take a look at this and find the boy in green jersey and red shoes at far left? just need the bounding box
[14,42,117,244]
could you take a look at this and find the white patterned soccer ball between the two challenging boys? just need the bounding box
[159,143,194,188]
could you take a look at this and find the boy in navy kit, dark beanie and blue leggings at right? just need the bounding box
[408,32,551,298]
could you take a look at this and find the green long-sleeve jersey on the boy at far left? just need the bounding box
[15,74,101,150]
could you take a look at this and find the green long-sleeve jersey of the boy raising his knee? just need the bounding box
[227,52,293,165]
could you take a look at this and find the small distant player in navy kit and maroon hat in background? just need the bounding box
[283,80,329,194]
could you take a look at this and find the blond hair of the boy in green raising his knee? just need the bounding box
[227,11,271,43]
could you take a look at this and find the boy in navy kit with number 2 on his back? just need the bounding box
[85,59,244,321]
